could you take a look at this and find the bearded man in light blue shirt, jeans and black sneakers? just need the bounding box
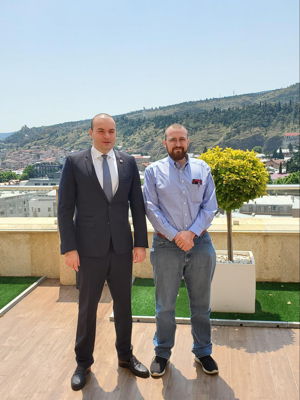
[144,124,218,377]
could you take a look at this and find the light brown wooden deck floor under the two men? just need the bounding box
[0,280,299,400]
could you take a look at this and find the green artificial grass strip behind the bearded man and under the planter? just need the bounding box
[132,278,300,322]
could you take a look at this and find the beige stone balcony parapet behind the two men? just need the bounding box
[0,217,300,285]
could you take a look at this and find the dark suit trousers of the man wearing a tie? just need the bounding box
[75,249,132,368]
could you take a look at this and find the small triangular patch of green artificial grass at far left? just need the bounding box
[0,276,39,309]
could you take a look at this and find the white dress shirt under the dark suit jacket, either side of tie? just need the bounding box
[91,146,119,195]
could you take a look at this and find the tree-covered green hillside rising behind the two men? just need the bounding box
[0,83,299,158]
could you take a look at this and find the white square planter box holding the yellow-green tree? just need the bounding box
[211,250,256,313]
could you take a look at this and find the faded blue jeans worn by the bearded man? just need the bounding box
[150,233,216,359]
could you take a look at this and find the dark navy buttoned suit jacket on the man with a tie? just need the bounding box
[58,149,148,257]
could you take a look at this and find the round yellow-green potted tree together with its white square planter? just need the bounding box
[200,147,269,312]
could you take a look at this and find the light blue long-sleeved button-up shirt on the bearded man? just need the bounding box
[143,156,218,240]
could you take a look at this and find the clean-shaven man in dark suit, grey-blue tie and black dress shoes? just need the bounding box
[58,114,149,390]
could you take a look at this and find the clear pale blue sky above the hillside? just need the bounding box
[0,0,299,132]
